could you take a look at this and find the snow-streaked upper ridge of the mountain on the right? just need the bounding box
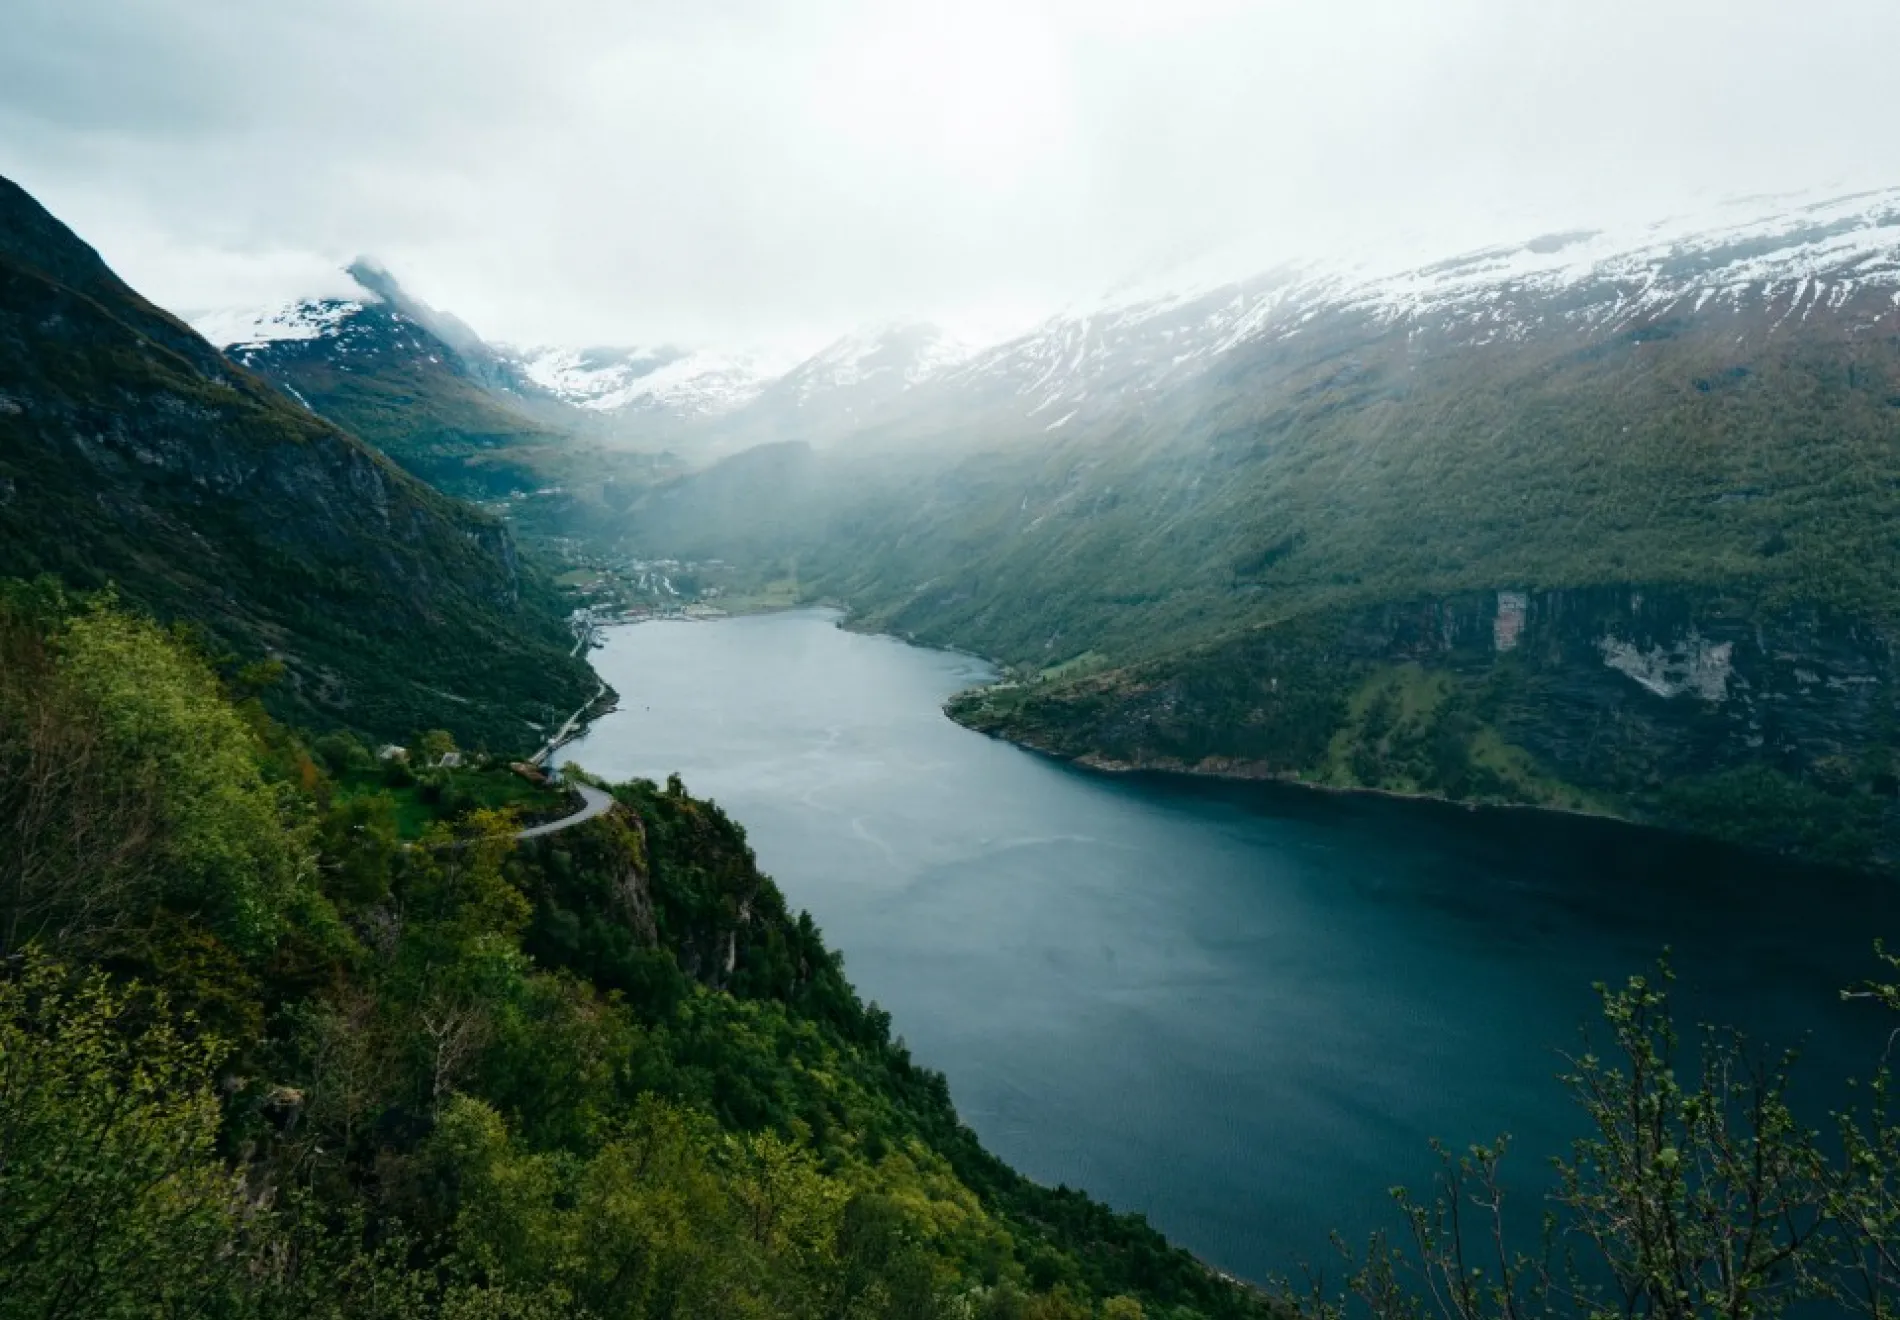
[937,188,1900,429]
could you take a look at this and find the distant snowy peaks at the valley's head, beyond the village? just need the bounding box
[198,281,969,486]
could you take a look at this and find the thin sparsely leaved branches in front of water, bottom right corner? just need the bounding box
[1283,959,1900,1320]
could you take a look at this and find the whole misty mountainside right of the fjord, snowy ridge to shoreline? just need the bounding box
[629,194,1900,862]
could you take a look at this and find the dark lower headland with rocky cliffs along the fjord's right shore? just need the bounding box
[952,585,1900,868]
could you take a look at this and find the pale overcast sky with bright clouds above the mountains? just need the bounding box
[0,0,1900,344]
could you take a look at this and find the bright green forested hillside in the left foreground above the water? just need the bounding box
[0,581,1265,1318]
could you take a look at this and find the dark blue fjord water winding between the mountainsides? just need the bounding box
[568,612,1900,1278]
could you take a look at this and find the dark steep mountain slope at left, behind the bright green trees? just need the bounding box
[0,180,593,746]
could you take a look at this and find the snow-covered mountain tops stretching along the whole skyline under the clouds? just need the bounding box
[198,188,1900,469]
